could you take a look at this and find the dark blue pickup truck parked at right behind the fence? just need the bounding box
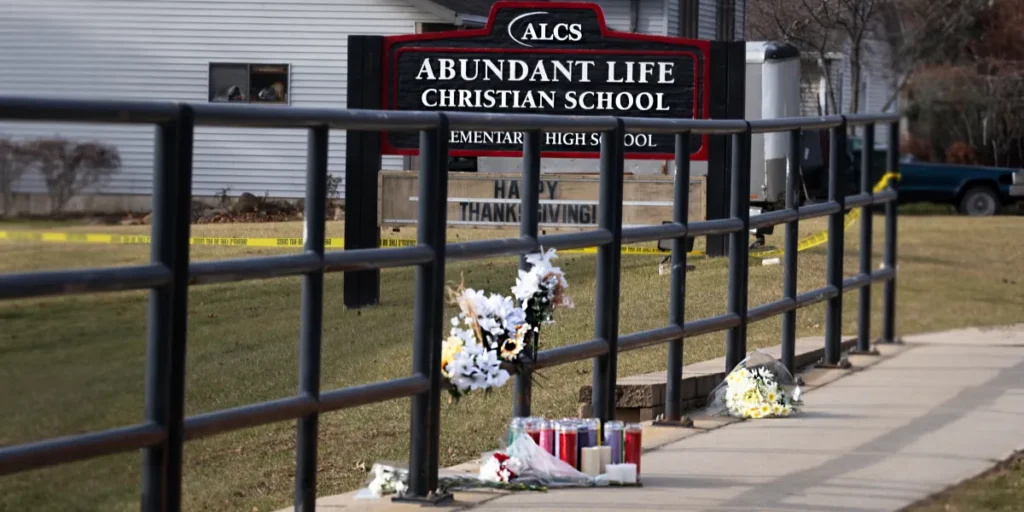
[803,137,1024,216]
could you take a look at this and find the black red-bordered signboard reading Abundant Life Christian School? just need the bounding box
[381,2,710,160]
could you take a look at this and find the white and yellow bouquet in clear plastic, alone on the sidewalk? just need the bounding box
[708,350,802,420]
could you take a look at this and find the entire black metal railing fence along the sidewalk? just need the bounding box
[0,97,898,511]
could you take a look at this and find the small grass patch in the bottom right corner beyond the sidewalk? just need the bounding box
[904,452,1024,512]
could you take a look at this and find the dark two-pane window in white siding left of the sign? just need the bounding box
[210,62,289,103]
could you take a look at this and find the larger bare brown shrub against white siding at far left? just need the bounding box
[25,138,121,213]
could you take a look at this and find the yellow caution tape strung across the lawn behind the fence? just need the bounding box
[0,172,899,258]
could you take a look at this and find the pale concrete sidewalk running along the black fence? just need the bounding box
[473,326,1024,511]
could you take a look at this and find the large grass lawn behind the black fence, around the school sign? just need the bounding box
[6,217,1024,511]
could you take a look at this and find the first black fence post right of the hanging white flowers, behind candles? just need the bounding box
[591,119,626,423]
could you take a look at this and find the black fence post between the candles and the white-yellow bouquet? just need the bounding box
[658,132,693,427]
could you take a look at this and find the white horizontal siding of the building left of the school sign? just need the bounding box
[0,0,450,198]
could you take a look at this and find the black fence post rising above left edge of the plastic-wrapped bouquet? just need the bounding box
[725,123,751,372]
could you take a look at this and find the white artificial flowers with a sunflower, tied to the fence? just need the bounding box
[441,249,572,399]
